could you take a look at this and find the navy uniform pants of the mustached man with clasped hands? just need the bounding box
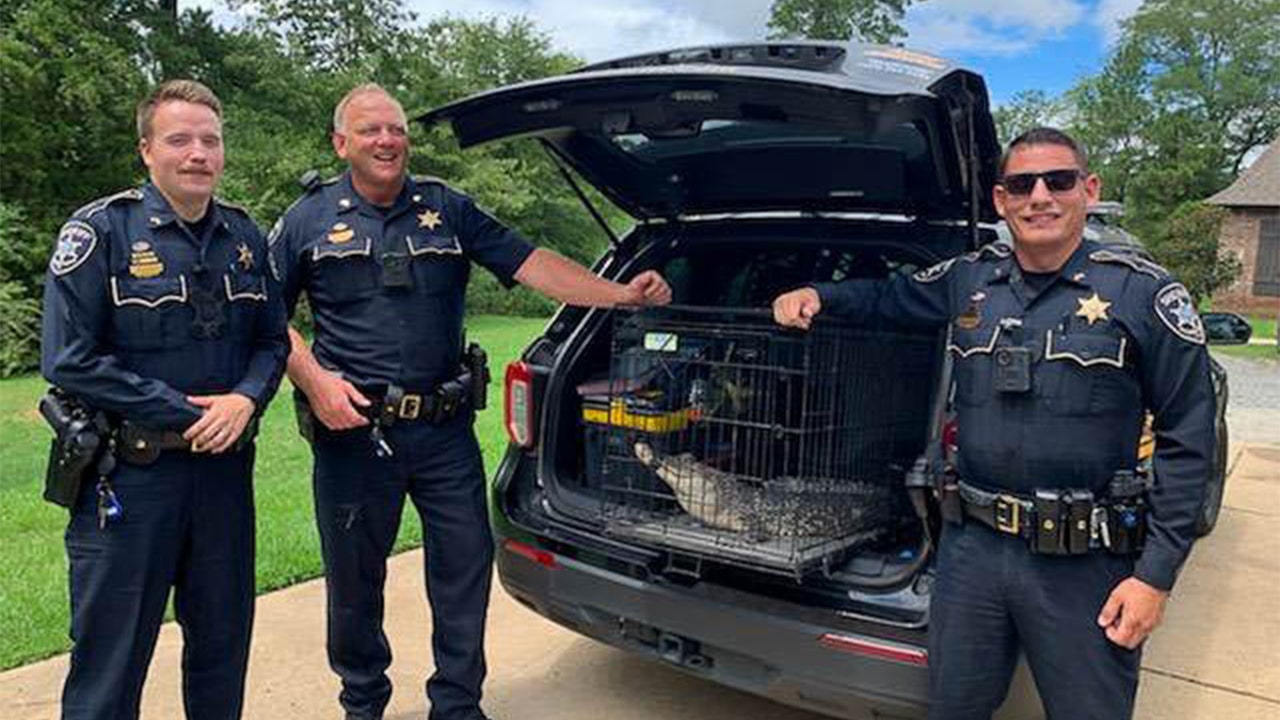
[63,450,253,720]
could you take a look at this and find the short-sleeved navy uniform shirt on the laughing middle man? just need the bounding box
[270,173,534,391]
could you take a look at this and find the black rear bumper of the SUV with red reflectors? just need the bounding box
[490,443,1043,720]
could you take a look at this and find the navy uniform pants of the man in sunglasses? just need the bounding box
[929,521,1142,720]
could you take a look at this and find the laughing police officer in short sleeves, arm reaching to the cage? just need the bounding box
[270,85,671,720]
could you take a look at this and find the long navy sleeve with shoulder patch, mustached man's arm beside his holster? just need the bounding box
[40,214,201,432]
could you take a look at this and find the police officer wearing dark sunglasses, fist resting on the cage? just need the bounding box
[774,128,1215,720]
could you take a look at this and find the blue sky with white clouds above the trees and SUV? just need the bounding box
[183,0,1140,104]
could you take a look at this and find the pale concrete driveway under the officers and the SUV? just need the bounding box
[0,443,1280,720]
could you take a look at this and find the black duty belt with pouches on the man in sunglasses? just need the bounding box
[959,482,1147,555]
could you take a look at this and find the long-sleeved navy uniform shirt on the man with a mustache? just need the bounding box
[41,183,289,432]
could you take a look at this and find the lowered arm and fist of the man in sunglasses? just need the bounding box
[1098,277,1216,647]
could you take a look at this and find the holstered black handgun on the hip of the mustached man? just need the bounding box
[40,388,111,507]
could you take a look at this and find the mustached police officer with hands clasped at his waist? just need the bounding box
[41,81,288,720]
